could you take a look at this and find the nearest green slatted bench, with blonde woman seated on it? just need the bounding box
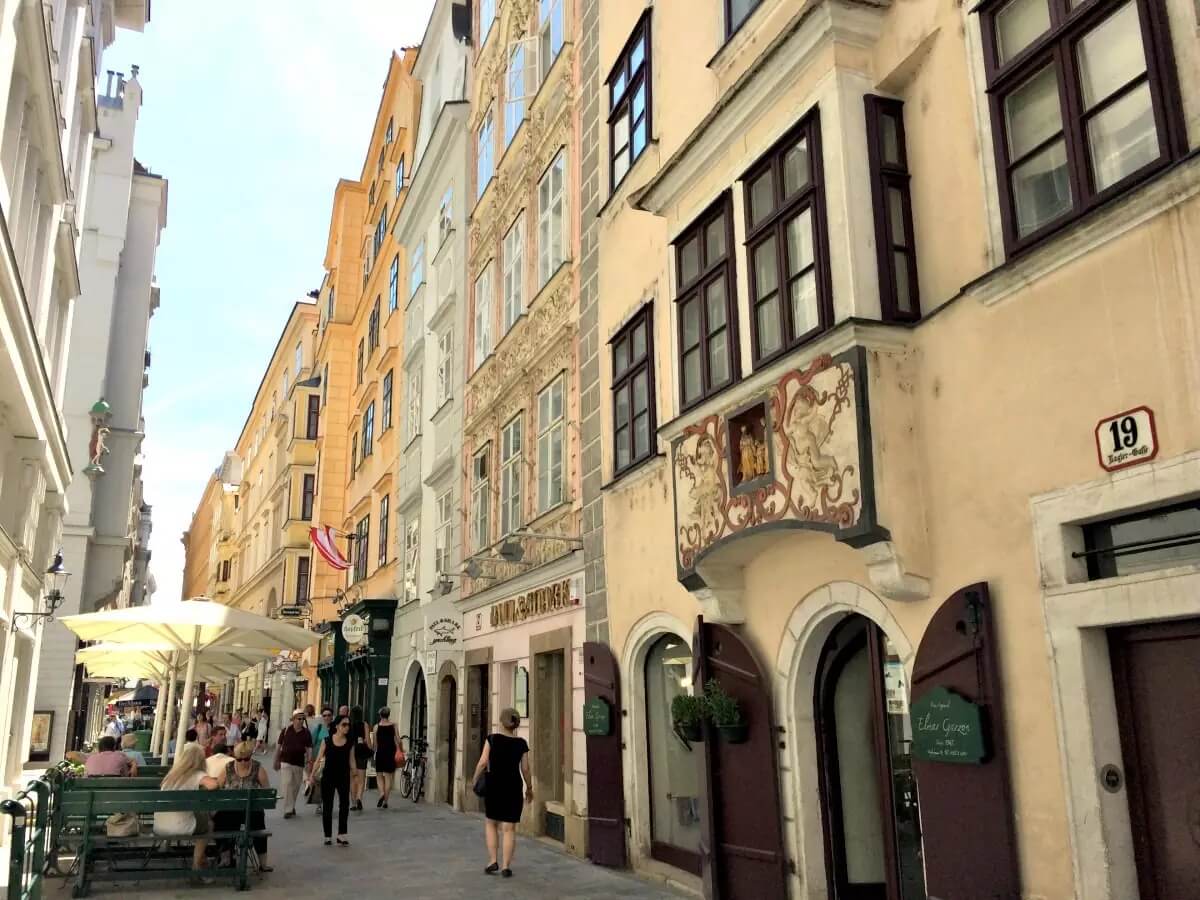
[60,779,276,896]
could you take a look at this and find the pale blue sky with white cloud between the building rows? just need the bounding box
[108,0,433,607]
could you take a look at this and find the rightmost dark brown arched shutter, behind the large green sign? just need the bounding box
[912,583,1028,900]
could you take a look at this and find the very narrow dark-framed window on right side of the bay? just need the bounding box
[864,95,920,322]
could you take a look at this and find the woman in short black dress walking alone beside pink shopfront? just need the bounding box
[472,709,533,878]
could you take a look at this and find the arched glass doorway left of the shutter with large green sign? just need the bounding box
[814,614,926,900]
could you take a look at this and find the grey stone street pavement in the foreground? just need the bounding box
[88,792,688,900]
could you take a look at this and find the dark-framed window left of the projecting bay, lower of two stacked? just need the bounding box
[611,304,654,474]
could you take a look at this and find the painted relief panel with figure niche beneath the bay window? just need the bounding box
[672,350,876,580]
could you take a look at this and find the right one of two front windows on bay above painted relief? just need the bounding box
[743,110,833,366]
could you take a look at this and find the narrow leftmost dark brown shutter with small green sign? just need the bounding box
[583,641,625,868]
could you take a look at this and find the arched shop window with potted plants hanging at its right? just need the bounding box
[646,635,701,869]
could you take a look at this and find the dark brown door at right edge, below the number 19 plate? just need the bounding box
[1109,619,1200,900]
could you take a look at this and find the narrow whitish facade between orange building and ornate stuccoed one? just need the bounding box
[389,0,472,805]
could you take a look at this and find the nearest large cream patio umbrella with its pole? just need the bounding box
[60,598,320,746]
